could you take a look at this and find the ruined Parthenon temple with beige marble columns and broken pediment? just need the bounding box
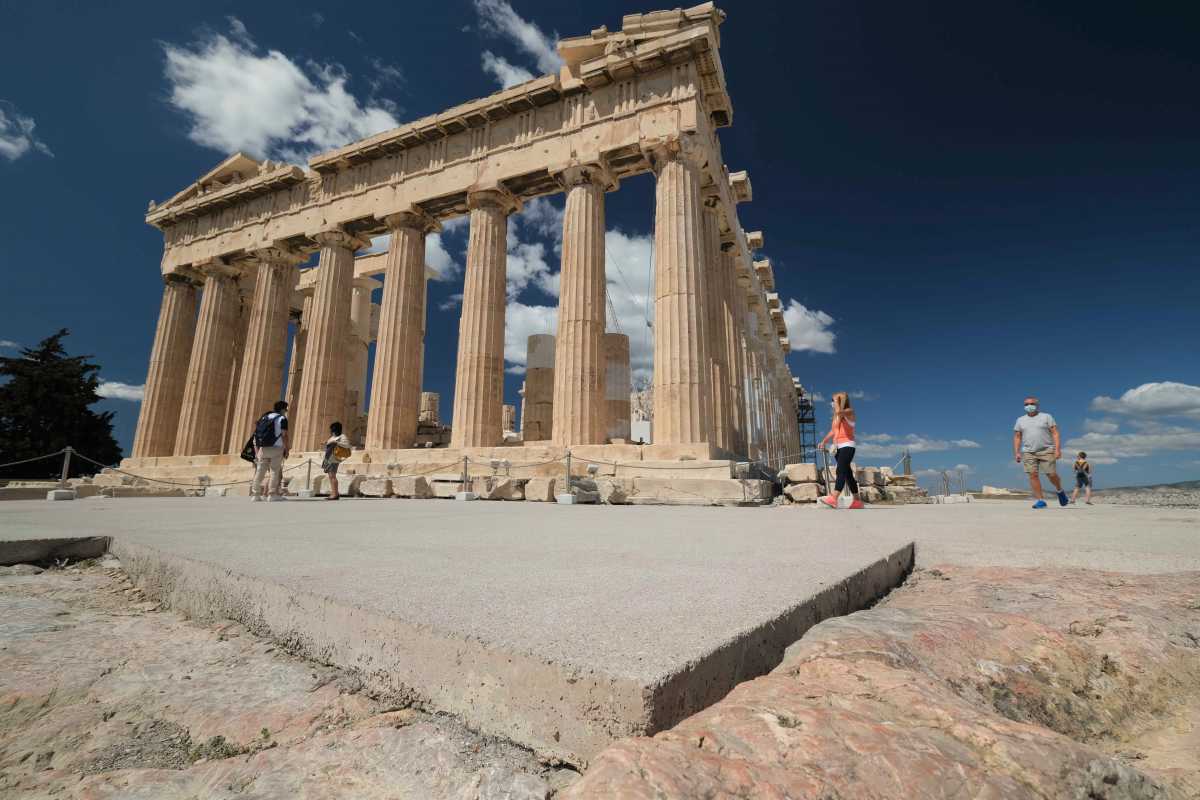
[128,2,799,489]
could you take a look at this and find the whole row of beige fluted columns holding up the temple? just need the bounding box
[133,137,798,461]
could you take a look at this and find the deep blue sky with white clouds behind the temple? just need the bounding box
[0,0,1200,486]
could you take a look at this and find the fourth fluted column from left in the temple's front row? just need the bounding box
[293,230,368,451]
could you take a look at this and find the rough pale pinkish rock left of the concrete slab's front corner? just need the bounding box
[0,561,561,800]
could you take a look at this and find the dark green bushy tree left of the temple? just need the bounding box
[0,327,121,479]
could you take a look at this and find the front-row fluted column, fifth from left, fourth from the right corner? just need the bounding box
[367,212,437,450]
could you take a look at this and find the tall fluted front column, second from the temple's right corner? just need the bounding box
[551,166,610,446]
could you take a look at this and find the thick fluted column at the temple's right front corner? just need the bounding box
[652,139,709,445]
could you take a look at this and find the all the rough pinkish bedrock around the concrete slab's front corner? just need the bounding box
[0,561,1200,800]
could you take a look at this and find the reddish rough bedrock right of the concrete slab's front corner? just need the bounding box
[563,567,1200,800]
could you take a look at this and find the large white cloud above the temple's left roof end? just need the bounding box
[163,18,398,162]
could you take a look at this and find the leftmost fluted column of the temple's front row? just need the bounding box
[133,275,196,458]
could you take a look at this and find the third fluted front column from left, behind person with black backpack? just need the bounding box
[229,247,301,453]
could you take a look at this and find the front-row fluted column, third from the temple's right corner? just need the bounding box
[450,190,518,447]
